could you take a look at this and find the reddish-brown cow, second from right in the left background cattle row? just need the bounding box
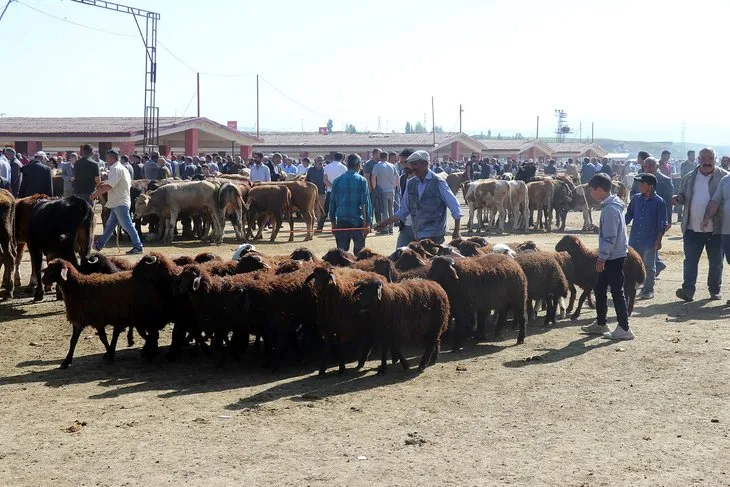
[246,184,290,242]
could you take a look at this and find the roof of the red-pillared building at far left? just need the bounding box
[0,117,258,143]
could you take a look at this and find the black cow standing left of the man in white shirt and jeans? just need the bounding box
[28,196,94,301]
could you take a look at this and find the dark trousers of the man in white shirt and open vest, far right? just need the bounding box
[682,229,722,297]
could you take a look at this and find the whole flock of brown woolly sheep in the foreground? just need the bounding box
[42,236,645,375]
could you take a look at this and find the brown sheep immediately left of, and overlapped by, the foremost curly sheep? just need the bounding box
[305,264,385,377]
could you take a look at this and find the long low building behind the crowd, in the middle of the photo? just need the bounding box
[254,132,484,161]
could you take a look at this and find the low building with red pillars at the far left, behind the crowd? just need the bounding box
[0,117,261,158]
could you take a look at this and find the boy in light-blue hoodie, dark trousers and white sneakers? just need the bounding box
[581,173,634,340]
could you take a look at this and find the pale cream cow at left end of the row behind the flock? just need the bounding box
[134,181,224,244]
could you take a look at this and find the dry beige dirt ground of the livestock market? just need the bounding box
[0,207,730,486]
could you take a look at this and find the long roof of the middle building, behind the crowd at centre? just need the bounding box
[255,132,482,150]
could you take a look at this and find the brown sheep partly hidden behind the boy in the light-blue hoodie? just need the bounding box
[555,235,646,320]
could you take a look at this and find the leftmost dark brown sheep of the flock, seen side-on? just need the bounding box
[41,259,167,369]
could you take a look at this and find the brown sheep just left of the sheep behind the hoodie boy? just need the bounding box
[515,252,568,326]
